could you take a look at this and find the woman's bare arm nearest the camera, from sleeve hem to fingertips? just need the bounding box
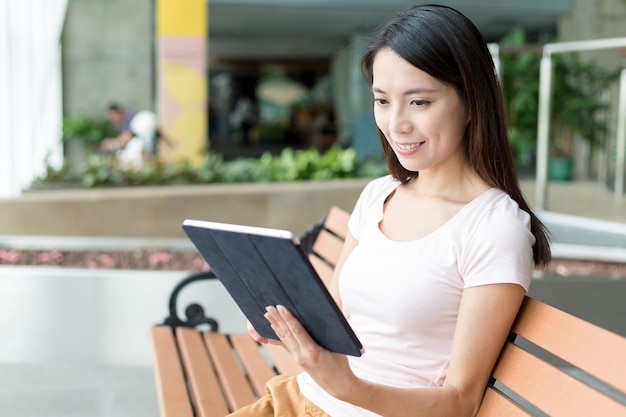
[266,284,525,417]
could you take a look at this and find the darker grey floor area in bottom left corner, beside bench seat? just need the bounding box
[0,362,158,417]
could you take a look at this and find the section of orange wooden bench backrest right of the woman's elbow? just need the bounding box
[478,297,626,417]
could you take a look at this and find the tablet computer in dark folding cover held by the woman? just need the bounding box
[182,219,362,356]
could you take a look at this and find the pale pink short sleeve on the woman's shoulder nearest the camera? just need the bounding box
[459,197,535,291]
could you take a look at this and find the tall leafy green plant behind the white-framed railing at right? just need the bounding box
[501,29,619,166]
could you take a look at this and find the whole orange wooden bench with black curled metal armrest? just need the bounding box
[151,208,626,417]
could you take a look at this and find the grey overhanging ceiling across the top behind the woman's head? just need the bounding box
[207,0,572,63]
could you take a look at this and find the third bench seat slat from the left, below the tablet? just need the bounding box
[203,332,256,411]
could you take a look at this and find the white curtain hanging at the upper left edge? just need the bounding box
[0,0,67,198]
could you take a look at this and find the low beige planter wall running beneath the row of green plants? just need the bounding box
[0,179,368,238]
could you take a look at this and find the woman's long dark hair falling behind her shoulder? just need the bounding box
[361,5,551,267]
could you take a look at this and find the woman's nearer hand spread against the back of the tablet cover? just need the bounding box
[265,305,358,399]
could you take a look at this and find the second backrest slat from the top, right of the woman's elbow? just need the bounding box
[493,343,626,417]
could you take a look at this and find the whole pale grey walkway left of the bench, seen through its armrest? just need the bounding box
[0,267,245,417]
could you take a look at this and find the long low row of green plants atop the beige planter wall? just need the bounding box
[35,146,387,188]
